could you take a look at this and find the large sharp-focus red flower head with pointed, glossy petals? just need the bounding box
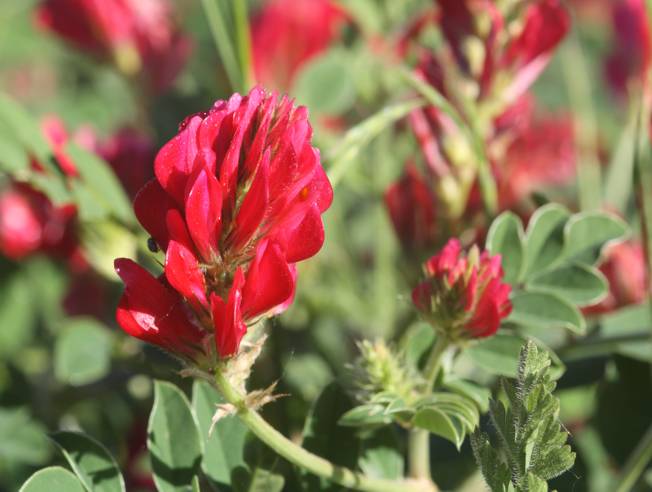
[116,88,332,361]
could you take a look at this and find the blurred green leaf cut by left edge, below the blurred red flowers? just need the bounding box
[0,271,36,359]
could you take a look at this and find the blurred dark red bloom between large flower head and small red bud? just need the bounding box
[385,163,437,250]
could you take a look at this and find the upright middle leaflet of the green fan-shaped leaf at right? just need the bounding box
[520,203,570,280]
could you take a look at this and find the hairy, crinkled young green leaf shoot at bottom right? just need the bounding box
[471,341,575,492]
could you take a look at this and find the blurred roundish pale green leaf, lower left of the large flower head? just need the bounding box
[54,317,112,386]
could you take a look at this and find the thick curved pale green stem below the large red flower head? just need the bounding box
[215,371,433,492]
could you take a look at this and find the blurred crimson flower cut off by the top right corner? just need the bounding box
[605,0,652,95]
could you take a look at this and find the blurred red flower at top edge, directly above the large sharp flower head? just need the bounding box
[251,0,346,90]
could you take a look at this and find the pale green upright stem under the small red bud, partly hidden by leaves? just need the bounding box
[408,335,450,480]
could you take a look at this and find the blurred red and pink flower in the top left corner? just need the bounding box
[37,0,190,91]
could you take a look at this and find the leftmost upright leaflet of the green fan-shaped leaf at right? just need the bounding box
[485,212,524,284]
